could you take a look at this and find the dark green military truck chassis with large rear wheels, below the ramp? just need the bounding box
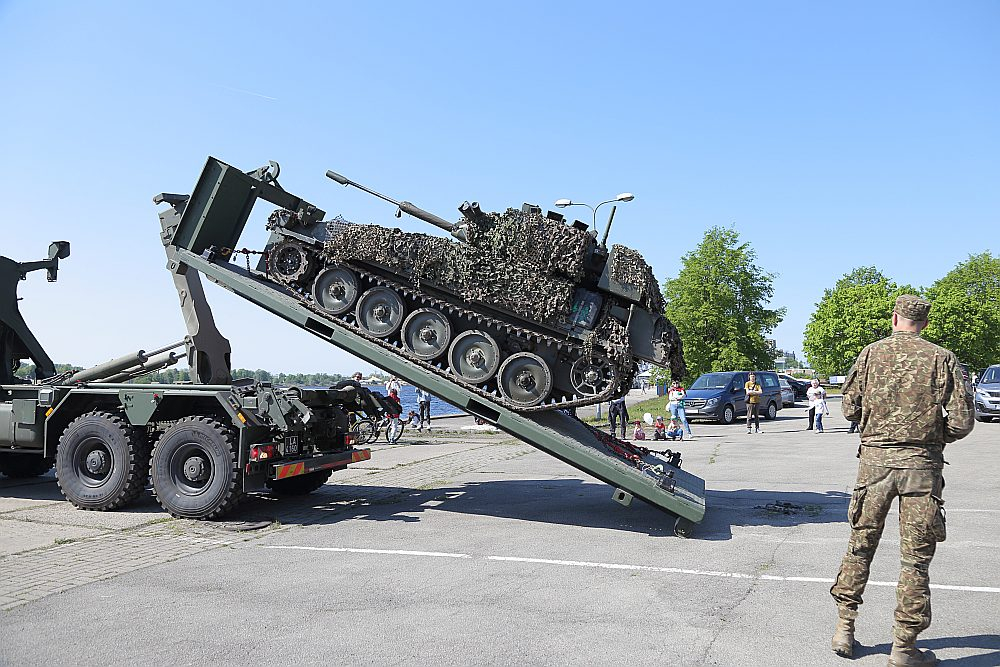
[0,241,388,519]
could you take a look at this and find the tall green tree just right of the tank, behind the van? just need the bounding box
[663,227,785,377]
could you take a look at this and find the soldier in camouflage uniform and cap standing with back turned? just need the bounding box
[830,294,974,667]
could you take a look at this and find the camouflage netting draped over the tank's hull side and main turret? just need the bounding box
[324,218,585,322]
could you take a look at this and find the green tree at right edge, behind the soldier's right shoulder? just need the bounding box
[924,251,1000,368]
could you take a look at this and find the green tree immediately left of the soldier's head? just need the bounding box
[802,266,917,375]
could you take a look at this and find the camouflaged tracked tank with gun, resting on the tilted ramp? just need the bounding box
[258,171,684,412]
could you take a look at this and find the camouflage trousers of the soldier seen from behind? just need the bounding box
[830,463,945,644]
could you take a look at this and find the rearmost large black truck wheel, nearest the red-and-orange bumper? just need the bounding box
[149,416,243,519]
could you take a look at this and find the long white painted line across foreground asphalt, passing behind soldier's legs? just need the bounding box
[263,545,1000,594]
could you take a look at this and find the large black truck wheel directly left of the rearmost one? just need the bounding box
[56,410,149,511]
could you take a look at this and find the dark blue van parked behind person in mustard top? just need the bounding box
[684,371,783,424]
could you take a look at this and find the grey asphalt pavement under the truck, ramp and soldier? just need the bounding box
[0,396,1000,666]
